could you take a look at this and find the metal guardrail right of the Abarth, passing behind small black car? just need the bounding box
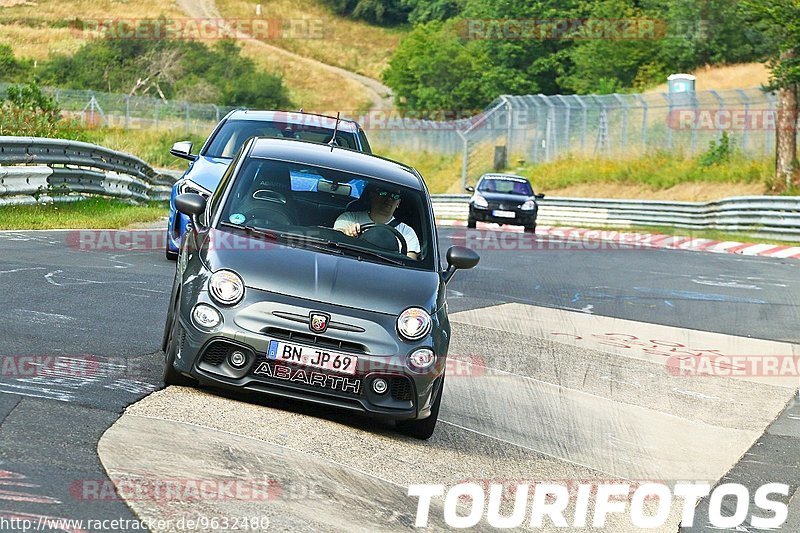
[433,194,800,242]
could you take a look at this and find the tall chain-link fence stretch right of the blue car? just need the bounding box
[368,88,784,187]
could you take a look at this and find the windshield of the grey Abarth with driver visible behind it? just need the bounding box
[219,158,435,270]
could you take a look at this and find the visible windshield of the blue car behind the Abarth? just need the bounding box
[204,120,358,159]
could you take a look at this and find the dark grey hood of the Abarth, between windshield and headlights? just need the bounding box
[200,229,444,315]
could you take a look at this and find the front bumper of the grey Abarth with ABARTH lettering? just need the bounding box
[175,289,446,420]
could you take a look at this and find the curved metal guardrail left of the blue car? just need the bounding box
[0,136,180,205]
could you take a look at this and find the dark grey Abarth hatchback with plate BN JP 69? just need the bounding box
[163,139,479,439]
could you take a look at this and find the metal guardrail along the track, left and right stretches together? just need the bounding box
[0,136,800,242]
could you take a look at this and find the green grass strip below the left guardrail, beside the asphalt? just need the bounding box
[0,198,168,230]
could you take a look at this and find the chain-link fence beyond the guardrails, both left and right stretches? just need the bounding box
[0,80,796,183]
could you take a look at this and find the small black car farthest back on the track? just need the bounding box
[466,174,544,233]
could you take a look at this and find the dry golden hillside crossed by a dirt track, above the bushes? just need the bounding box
[0,0,403,112]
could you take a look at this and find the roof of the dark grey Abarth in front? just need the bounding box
[249,137,424,190]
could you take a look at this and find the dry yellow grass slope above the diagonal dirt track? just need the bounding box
[217,0,408,79]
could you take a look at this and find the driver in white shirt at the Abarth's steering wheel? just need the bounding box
[333,187,420,259]
